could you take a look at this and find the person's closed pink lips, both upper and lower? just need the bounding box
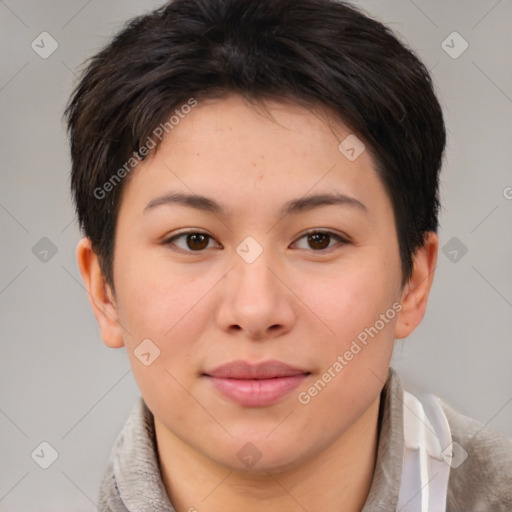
[205,360,310,407]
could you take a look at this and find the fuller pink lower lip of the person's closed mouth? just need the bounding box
[208,374,308,407]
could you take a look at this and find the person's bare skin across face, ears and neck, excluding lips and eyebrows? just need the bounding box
[77,96,438,512]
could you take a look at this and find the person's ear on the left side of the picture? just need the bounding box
[76,238,124,348]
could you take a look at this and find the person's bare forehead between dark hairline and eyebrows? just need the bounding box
[119,96,391,224]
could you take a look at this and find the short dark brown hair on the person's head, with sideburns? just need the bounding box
[65,0,446,287]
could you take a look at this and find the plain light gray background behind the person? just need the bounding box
[0,0,512,512]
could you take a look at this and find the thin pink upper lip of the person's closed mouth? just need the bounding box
[205,360,310,379]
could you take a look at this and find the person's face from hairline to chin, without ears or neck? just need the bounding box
[103,96,408,470]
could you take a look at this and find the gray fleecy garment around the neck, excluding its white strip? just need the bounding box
[98,368,512,512]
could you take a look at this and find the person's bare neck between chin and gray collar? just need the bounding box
[155,397,380,512]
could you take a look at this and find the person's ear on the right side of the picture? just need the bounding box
[395,231,439,339]
